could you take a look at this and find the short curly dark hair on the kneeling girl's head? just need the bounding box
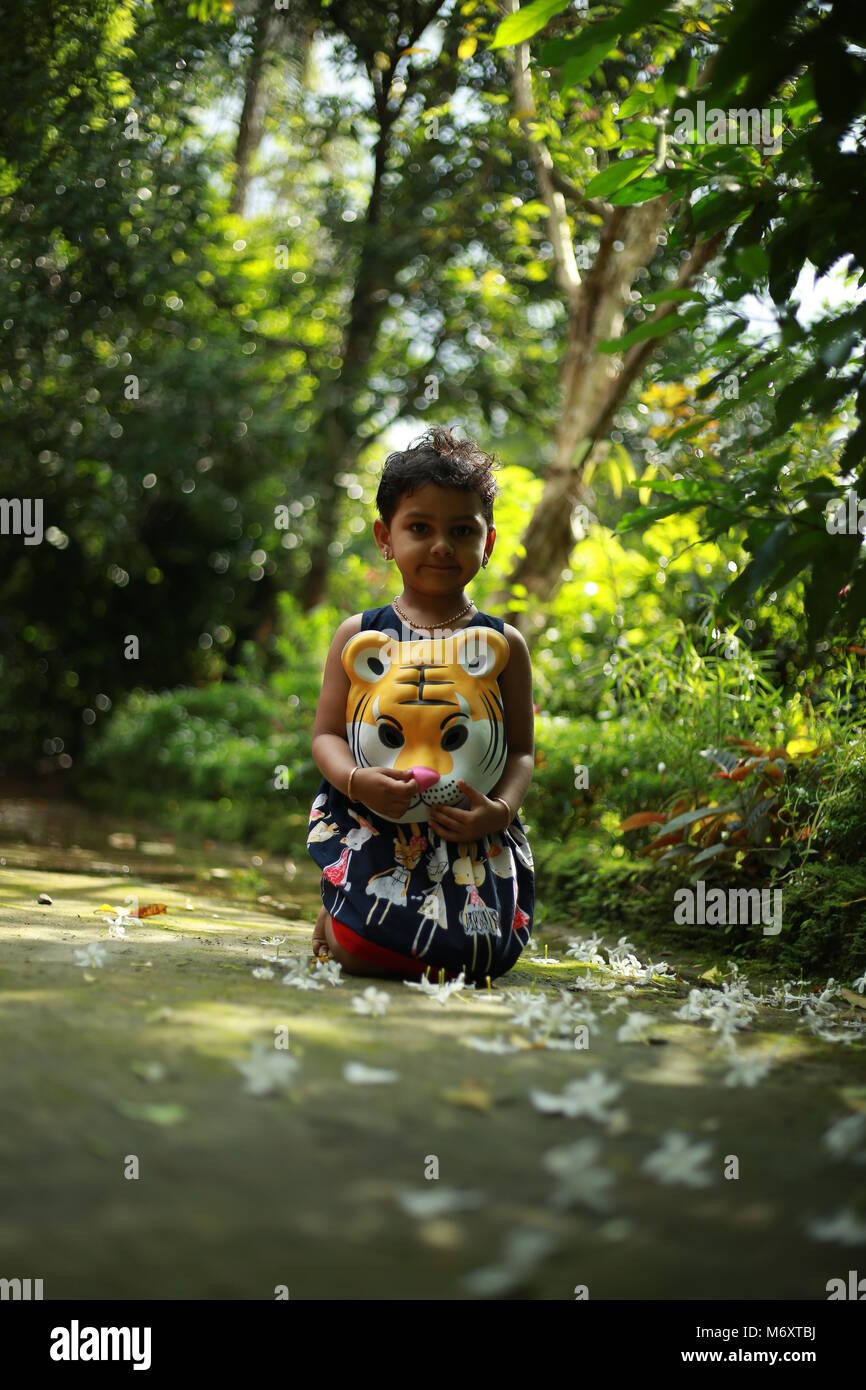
[375,425,499,527]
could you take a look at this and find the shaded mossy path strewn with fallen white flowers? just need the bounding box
[0,819,866,1300]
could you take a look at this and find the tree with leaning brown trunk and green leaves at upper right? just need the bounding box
[495,0,866,639]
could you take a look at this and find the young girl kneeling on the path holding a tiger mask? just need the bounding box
[307,427,535,984]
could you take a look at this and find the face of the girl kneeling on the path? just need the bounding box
[374,482,496,595]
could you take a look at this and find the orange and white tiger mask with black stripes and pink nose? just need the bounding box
[342,627,510,823]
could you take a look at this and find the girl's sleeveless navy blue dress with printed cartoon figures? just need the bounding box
[307,603,535,983]
